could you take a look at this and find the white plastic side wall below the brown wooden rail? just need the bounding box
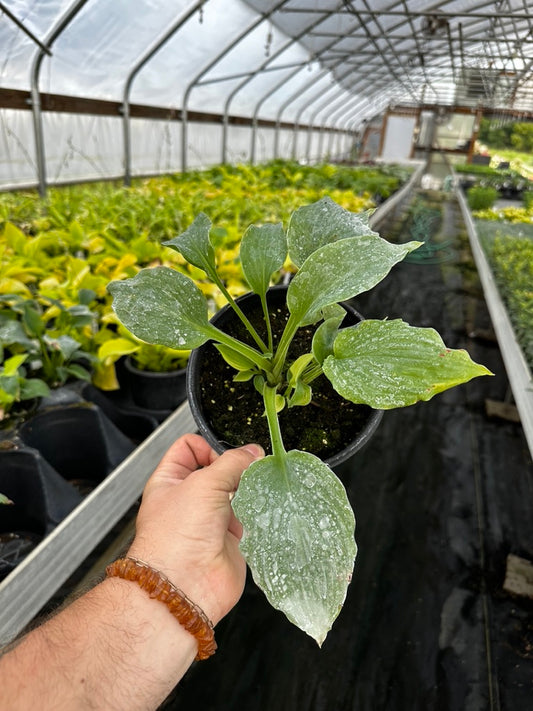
[0,111,340,189]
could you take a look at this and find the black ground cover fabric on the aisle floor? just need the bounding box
[162,192,533,711]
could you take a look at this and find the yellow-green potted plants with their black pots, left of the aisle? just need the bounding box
[0,162,407,584]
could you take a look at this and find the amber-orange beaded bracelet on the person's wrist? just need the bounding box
[106,557,217,660]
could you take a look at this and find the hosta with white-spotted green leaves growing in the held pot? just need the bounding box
[109,197,489,644]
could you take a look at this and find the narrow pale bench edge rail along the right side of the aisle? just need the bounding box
[457,191,533,456]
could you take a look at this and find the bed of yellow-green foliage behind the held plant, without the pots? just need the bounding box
[0,161,409,406]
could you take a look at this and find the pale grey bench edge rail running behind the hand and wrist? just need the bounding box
[0,402,196,645]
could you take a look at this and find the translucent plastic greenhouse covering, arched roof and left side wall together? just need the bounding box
[0,0,533,191]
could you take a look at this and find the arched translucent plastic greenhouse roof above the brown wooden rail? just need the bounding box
[0,0,533,126]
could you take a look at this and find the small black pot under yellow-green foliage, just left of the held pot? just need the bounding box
[124,357,187,419]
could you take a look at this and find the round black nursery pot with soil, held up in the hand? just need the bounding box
[187,286,383,466]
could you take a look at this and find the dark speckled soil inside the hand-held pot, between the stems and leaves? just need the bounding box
[195,291,372,459]
